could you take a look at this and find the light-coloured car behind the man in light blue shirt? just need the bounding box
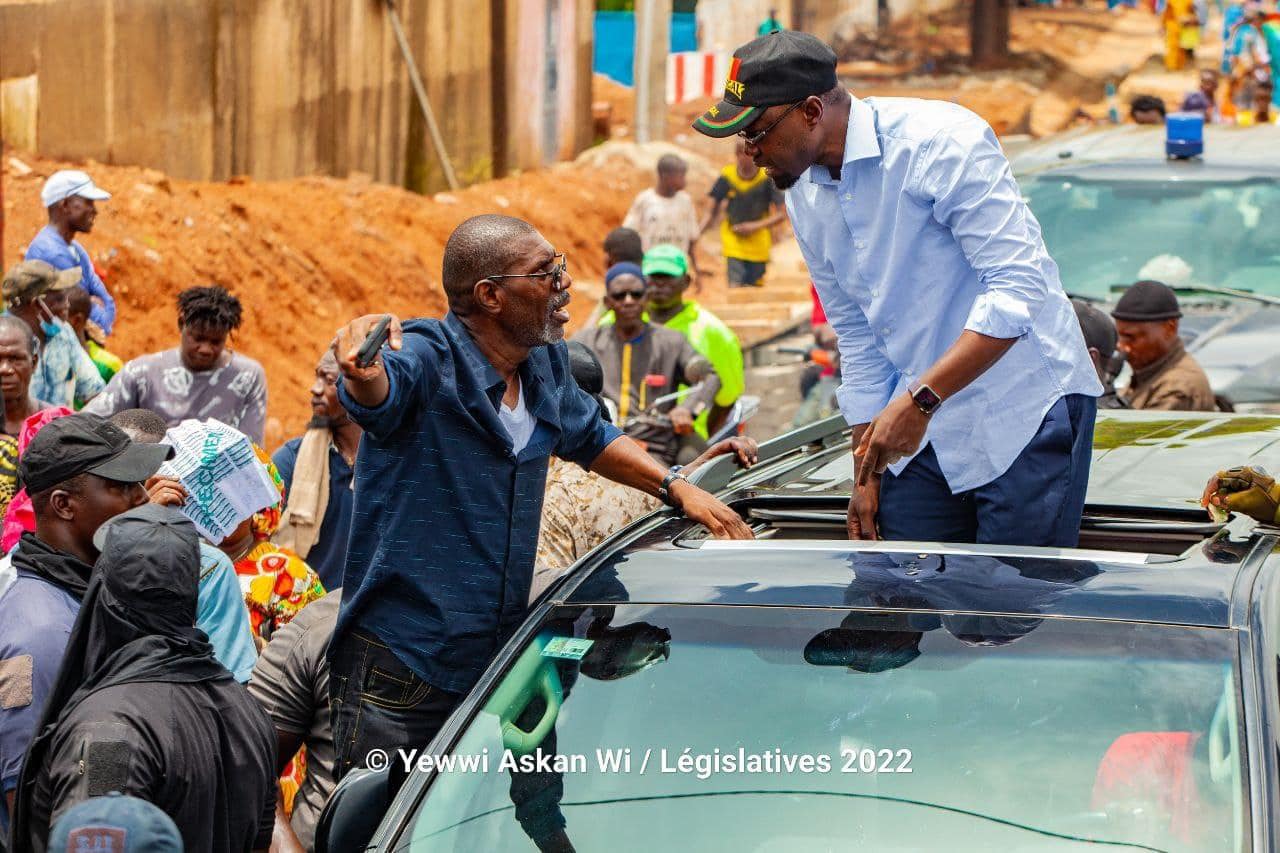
[1011,126,1280,411]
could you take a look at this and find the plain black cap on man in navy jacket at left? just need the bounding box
[18,412,173,494]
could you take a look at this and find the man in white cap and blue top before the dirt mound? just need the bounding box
[26,169,115,334]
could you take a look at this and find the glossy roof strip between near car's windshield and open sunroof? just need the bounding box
[563,540,1243,628]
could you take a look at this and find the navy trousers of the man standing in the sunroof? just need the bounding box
[877,394,1098,548]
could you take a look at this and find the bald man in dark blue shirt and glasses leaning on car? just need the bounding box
[329,215,751,819]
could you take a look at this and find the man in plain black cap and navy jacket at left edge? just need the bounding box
[0,414,173,836]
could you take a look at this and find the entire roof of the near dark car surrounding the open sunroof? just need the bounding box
[553,410,1280,628]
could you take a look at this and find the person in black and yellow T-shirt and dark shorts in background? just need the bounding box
[703,140,787,287]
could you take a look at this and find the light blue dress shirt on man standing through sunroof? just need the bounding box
[787,97,1102,493]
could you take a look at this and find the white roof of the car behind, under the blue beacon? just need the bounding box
[1010,124,1280,181]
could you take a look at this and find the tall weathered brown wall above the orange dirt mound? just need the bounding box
[0,0,591,191]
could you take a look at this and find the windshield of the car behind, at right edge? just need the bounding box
[1020,175,1280,297]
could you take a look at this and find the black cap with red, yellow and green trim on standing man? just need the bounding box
[694,29,838,138]
